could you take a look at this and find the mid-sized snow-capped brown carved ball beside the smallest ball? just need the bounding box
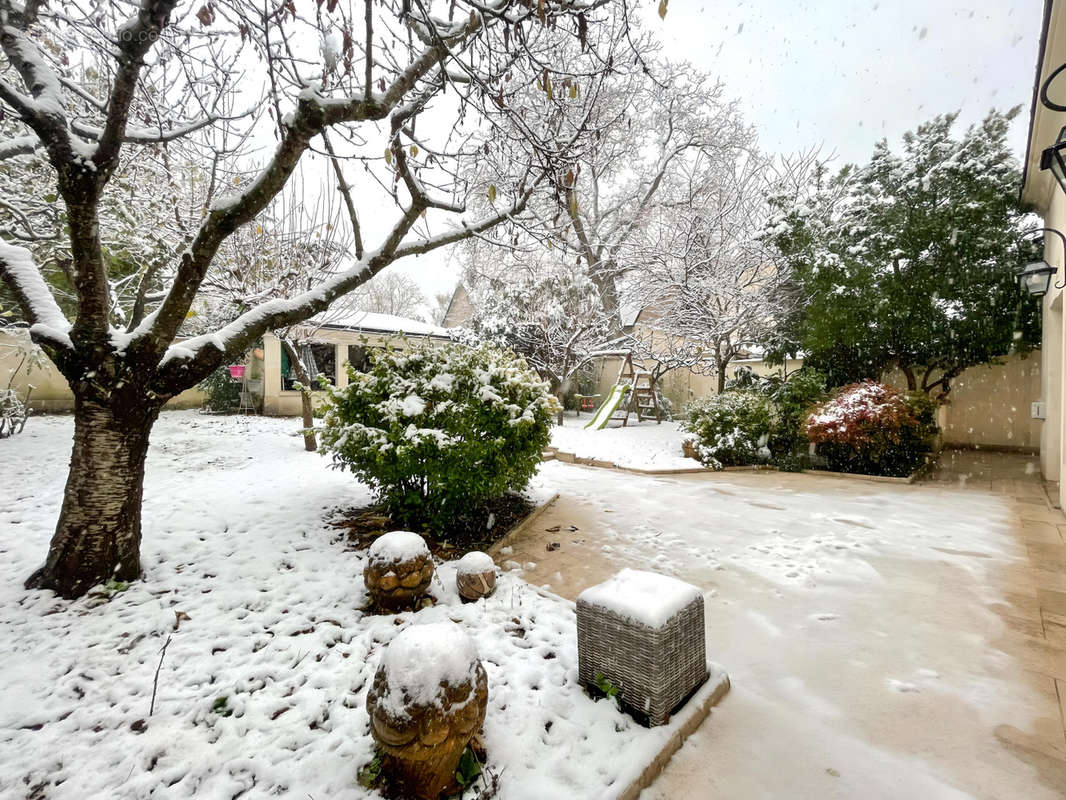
[362,530,433,611]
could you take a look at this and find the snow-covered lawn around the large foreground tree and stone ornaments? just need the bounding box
[0,412,720,800]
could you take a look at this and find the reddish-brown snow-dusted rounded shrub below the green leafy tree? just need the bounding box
[806,381,936,476]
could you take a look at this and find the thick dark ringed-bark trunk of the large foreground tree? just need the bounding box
[26,396,160,598]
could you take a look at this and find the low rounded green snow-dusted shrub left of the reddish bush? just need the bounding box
[681,390,770,469]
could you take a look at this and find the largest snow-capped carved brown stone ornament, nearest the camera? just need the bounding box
[367,622,488,800]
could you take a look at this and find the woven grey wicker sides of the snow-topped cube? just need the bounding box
[577,596,708,726]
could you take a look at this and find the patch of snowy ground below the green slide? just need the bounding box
[551,413,699,469]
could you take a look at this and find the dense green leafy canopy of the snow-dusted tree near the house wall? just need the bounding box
[769,109,1039,396]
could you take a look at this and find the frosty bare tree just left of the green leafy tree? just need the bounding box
[626,151,810,391]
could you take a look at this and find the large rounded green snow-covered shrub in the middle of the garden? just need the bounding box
[322,345,556,532]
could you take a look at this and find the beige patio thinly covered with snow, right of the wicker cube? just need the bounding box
[511,462,1066,800]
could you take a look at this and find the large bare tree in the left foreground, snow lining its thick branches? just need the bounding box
[0,0,627,597]
